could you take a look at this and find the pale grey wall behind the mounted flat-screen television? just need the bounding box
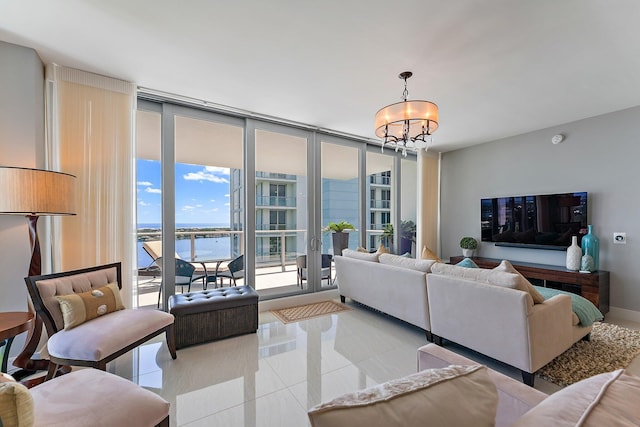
[441,107,640,311]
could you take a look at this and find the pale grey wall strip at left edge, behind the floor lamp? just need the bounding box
[0,42,44,356]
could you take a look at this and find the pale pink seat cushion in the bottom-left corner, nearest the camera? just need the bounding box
[30,368,169,427]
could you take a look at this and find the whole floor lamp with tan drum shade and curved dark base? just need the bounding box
[0,166,76,375]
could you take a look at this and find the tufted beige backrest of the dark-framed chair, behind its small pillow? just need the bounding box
[36,267,121,331]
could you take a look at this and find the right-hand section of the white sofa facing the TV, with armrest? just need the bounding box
[427,264,592,385]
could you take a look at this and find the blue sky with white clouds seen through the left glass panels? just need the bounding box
[137,159,229,226]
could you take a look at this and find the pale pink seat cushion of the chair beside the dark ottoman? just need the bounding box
[47,309,173,361]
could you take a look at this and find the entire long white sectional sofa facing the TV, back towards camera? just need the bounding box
[335,250,591,385]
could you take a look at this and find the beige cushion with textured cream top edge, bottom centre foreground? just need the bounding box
[308,365,498,427]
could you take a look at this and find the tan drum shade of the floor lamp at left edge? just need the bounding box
[0,166,76,216]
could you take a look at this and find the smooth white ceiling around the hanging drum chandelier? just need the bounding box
[0,0,640,151]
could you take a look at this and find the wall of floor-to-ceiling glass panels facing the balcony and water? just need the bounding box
[137,101,415,305]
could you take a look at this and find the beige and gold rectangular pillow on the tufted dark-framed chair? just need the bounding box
[56,283,124,329]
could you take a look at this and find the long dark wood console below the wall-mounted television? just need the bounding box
[450,256,609,314]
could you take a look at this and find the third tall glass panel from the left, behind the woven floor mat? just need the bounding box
[252,123,312,297]
